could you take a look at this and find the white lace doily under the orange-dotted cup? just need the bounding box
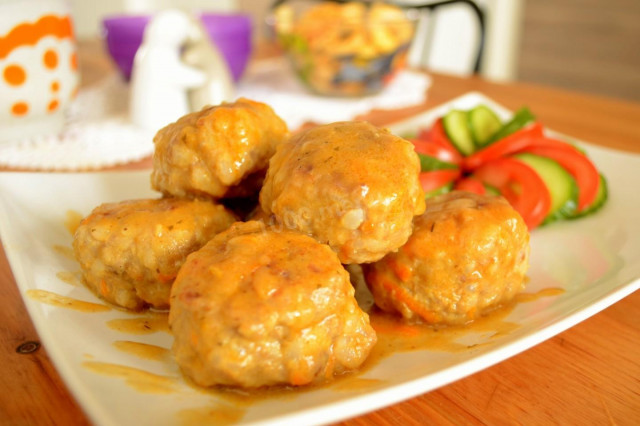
[0,75,154,170]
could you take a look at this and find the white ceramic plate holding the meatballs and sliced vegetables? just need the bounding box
[0,93,640,426]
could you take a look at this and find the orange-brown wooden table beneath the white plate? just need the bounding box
[0,40,640,425]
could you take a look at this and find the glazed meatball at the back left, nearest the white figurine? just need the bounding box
[151,98,288,198]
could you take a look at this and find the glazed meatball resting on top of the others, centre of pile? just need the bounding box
[260,122,425,264]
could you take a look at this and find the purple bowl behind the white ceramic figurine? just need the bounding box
[102,13,251,81]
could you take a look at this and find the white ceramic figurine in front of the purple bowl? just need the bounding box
[130,10,233,131]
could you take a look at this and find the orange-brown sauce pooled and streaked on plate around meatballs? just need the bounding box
[43,236,564,425]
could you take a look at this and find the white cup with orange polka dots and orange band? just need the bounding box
[0,0,78,142]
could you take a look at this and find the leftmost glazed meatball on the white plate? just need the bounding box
[73,198,236,310]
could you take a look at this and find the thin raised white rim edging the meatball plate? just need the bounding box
[0,91,640,425]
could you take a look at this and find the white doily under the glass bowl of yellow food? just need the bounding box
[236,57,431,129]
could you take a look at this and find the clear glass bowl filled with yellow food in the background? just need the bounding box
[271,0,417,96]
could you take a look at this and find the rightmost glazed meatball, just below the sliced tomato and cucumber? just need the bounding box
[364,191,529,324]
